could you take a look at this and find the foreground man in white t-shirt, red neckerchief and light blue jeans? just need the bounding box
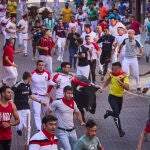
[47,86,85,150]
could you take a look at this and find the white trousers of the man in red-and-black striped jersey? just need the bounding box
[39,55,53,74]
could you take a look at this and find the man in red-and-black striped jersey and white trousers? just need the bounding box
[36,29,57,73]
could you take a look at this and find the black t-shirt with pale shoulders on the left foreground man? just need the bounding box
[12,80,32,110]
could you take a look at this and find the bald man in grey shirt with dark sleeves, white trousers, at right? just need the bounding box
[118,30,143,92]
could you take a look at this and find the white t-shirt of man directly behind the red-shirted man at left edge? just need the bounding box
[6,21,17,39]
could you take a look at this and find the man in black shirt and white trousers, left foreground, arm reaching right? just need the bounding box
[12,72,46,146]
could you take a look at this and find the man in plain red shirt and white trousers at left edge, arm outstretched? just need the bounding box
[2,38,23,85]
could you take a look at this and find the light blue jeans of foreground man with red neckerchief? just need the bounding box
[57,129,77,150]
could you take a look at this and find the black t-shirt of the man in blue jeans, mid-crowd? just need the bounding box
[67,33,80,50]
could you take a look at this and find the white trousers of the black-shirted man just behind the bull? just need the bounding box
[76,65,90,78]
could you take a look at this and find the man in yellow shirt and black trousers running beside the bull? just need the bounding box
[100,62,129,137]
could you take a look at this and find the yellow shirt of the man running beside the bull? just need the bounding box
[109,73,129,97]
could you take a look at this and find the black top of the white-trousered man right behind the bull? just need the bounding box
[78,45,89,67]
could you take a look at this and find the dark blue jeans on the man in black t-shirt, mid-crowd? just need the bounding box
[69,47,77,68]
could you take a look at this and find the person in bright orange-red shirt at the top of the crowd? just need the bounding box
[99,2,108,22]
